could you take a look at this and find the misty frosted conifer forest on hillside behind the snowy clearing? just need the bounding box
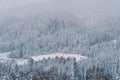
[0,15,120,57]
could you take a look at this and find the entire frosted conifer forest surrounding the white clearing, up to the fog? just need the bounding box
[0,15,120,80]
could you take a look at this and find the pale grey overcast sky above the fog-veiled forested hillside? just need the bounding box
[0,0,120,15]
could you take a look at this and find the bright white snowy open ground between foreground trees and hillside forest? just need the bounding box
[0,52,87,65]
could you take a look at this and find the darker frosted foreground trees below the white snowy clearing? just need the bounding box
[0,57,120,80]
